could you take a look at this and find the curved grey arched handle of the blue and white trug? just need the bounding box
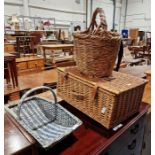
[17,86,57,119]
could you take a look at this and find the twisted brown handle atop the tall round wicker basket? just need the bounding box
[87,8,107,31]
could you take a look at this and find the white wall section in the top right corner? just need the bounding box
[122,0,151,31]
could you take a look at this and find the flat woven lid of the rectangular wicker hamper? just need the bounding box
[58,67,148,94]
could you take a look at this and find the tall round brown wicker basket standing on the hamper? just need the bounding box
[73,8,120,77]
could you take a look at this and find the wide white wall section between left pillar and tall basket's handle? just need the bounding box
[29,0,86,21]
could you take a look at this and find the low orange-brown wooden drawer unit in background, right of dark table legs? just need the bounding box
[16,56,44,74]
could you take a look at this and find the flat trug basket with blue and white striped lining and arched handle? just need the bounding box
[6,86,82,148]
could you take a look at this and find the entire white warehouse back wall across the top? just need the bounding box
[4,0,151,31]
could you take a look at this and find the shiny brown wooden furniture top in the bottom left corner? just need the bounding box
[4,113,35,155]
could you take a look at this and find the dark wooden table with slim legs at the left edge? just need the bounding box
[4,53,18,87]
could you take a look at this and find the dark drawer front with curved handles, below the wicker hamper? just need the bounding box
[101,116,144,155]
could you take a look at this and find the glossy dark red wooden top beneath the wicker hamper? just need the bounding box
[5,102,149,155]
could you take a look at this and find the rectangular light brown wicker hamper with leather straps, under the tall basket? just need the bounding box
[57,67,146,129]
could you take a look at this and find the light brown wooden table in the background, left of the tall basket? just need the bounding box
[40,44,74,62]
